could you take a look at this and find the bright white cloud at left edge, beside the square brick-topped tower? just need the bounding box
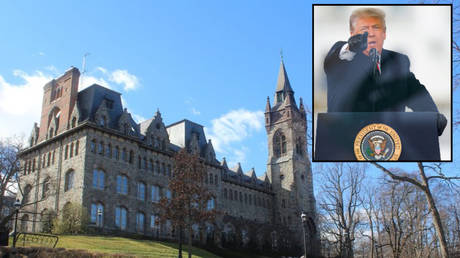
[0,70,52,137]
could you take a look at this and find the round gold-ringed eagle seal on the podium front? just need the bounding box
[353,124,402,161]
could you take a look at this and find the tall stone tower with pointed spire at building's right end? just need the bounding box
[265,60,319,255]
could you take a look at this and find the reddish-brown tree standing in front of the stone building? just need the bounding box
[160,149,216,257]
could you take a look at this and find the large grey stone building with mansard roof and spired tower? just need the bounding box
[20,62,318,254]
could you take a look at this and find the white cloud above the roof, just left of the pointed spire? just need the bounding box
[205,109,264,164]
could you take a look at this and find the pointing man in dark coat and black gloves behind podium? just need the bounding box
[324,8,438,113]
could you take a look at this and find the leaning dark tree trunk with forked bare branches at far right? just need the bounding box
[372,162,460,258]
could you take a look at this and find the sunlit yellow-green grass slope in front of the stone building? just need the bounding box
[15,236,218,257]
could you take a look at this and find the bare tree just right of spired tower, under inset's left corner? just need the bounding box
[319,163,365,257]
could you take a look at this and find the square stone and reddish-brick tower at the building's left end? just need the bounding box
[35,67,80,142]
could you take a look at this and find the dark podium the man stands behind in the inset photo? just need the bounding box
[314,112,441,161]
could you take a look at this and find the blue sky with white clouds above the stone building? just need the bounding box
[0,0,458,181]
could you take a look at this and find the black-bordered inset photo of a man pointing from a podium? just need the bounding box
[313,5,452,162]
